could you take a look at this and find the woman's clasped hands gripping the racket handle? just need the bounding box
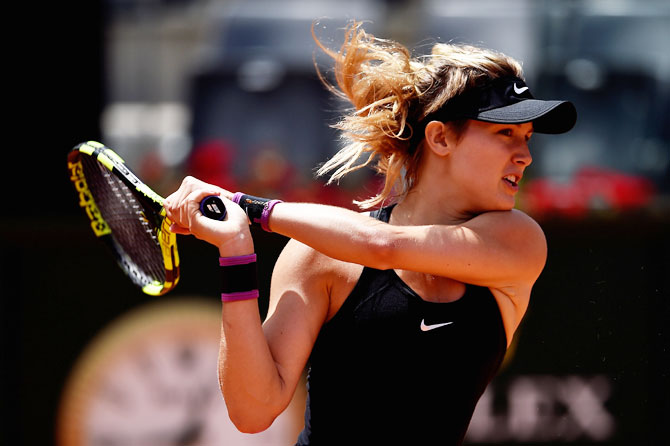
[163,177,254,257]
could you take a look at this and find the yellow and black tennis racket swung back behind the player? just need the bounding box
[67,141,226,296]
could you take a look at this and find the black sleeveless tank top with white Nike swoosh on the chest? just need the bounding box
[297,206,507,446]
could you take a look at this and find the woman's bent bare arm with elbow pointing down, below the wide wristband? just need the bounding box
[219,242,328,433]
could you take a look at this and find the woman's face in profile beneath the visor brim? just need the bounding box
[450,121,533,212]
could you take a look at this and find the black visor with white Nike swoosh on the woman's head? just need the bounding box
[424,77,577,134]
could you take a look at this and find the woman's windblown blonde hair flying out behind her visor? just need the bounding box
[312,22,523,209]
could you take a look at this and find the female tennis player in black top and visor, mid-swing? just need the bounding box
[166,23,576,445]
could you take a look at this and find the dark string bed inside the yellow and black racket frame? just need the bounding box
[82,157,165,286]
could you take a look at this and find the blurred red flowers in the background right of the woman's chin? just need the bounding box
[523,167,656,217]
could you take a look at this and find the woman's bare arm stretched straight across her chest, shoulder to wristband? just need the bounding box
[270,203,546,288]
